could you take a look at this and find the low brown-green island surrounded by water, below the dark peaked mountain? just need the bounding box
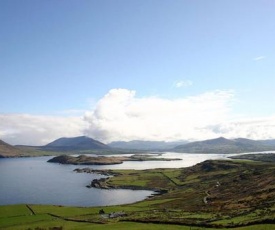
[48,154,181,165]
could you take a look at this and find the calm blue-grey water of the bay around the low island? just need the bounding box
[0,153,229,206]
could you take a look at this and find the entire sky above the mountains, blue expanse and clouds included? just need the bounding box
[0,0,275,145]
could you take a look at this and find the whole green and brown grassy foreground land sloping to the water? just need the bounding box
[0,160,275,230]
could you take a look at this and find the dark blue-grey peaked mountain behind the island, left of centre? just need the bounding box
[41,136,110,151]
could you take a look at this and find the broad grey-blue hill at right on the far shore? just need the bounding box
[175,137,275,154]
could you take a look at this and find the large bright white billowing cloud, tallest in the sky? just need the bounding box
[85,89,234,142]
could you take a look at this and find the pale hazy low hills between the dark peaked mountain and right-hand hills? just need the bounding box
[108,140,186,150]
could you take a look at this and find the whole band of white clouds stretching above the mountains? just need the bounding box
[0,89,275,145]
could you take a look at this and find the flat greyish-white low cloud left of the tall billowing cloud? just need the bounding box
[0,114,86,145]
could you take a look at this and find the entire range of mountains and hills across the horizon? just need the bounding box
[0,136,275,157]
